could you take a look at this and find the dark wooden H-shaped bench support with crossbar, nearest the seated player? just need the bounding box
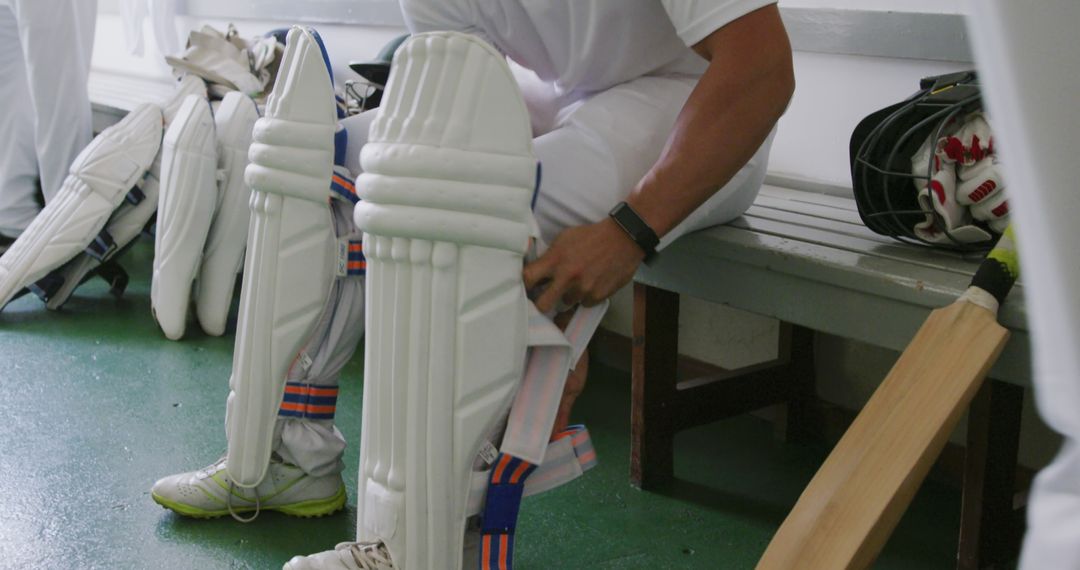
[630,283,814,489]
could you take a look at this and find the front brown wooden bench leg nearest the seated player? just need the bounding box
[630,283,678,489]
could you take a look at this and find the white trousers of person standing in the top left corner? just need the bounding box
[0,0,97,236]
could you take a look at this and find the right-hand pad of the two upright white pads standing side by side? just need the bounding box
[195,92,259,336]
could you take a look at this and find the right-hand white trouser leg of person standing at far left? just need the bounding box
[12,0,97,202]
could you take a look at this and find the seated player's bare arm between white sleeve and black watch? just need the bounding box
[627,6,794,236]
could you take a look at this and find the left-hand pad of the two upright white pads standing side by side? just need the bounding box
[150,95,217,340]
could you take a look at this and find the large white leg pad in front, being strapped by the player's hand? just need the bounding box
[355,32,540,570]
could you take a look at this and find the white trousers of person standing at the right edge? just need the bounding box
[968,0,1080,570]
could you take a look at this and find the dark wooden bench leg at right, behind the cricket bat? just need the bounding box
[957,379,1024,570]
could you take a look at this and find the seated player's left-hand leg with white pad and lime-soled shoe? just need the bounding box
[152,28,366,517]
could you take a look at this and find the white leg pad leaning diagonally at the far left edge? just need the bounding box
[0,105,162,307]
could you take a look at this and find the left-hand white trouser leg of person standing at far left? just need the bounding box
[0,5,40,237]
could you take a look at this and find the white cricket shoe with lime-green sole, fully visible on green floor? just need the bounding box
[150,458,346,523]
